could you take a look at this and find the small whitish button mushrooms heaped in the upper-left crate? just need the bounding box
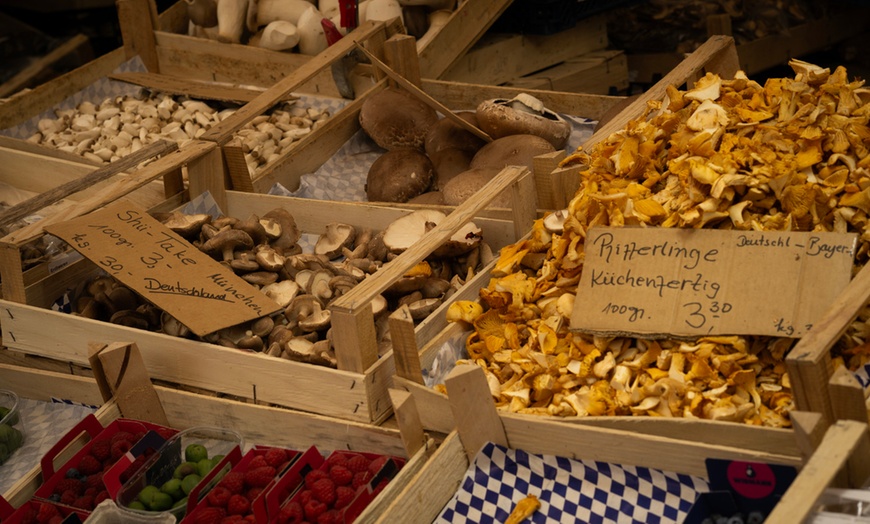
[28,91,330,173]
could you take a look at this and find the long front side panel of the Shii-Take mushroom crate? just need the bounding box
[0,301,369,422]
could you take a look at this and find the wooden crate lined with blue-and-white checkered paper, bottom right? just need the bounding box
[378,366,836,524]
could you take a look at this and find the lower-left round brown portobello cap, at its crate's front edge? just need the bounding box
[365,148,435,202]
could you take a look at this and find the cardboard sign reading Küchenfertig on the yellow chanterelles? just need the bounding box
[571,227,857,338]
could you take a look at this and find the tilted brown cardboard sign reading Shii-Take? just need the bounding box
[46,201,280,336]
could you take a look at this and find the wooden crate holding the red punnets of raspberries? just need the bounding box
[0,343,437,522]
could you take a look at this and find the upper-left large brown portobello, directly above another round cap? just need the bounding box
[359,87,438,150]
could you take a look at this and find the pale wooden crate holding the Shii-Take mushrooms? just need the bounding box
[0,161,534,422]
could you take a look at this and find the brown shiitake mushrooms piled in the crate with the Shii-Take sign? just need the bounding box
[70,208,493,367]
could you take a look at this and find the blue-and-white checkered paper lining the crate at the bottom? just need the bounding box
[435,442,708,524]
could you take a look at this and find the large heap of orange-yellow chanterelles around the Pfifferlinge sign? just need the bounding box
[448,60,870,427]
